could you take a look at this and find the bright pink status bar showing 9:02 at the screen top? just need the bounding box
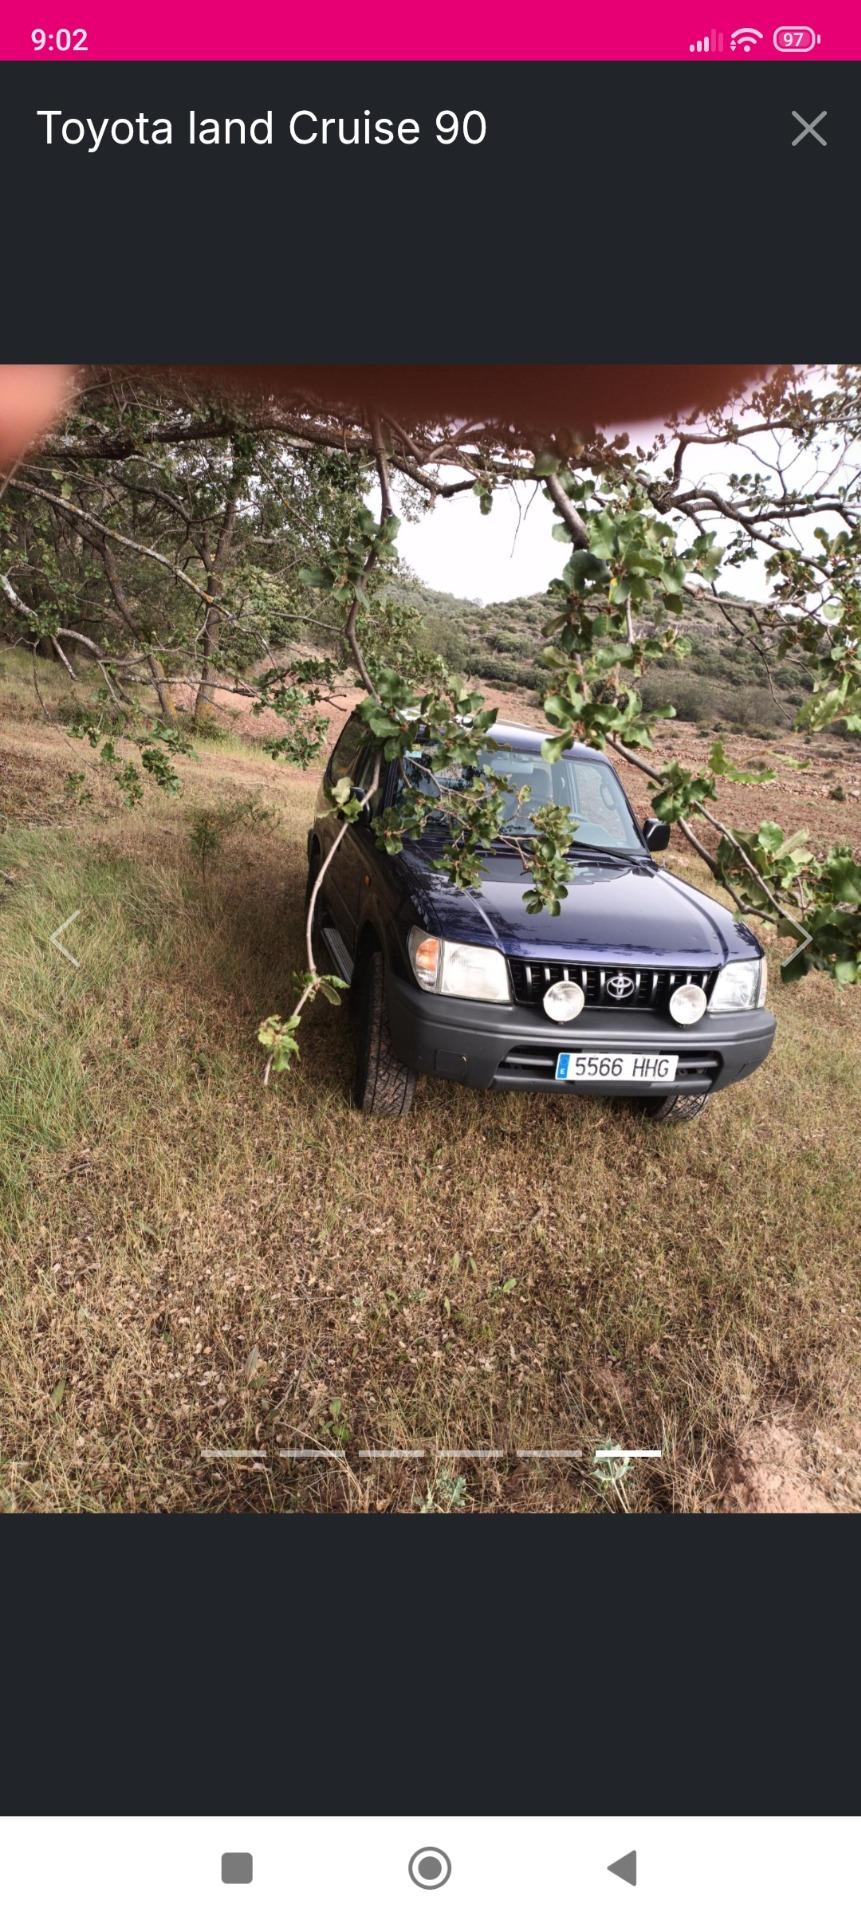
[0,0,861,65]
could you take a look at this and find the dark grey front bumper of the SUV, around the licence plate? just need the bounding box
[388,973,775,1100]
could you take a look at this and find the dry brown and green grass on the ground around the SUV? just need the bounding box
[0,675,861,1511]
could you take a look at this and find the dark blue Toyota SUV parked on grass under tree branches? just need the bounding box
[308,716,775,1119]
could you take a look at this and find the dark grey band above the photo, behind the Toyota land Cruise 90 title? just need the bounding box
[0,61,845,363]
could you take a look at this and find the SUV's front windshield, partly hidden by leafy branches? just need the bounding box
[406,745,642,852]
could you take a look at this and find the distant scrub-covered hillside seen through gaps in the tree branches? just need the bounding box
[400,578,809,728]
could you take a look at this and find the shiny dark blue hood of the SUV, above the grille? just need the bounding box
[400,843,761,968]
